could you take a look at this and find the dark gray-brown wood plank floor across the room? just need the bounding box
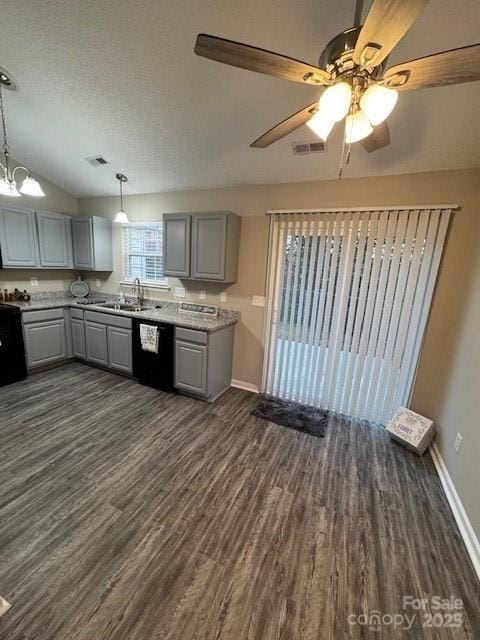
[0,364,480,640]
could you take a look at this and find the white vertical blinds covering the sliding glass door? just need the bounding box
[264,207,451,424]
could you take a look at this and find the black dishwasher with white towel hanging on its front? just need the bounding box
[133,318,174,391]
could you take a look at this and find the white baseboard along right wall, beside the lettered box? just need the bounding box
[430,443,480,580]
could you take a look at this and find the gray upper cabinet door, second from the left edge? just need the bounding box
[37,211,73,269]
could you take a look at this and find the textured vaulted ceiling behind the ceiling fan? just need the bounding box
[0,0,480,196]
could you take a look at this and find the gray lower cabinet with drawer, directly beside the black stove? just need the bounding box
[22,309,69,369]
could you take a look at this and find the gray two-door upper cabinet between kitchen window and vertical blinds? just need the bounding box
[163,211,240,282]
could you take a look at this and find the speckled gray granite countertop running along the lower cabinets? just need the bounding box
[10,298,240,331]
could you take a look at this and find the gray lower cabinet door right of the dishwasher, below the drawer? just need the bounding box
[175,340,207,396]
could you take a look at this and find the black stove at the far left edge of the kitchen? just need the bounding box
[0,304,27,386]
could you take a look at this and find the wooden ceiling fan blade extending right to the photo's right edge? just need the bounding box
[384,44,480,91]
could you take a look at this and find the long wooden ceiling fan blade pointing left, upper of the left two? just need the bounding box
[195,33,330,85]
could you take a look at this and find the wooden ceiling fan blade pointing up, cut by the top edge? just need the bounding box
[353,0,428,67]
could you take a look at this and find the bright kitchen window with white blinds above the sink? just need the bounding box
[122,222,168,287]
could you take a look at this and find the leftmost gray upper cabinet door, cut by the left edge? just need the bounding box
[0,207,39,269]
